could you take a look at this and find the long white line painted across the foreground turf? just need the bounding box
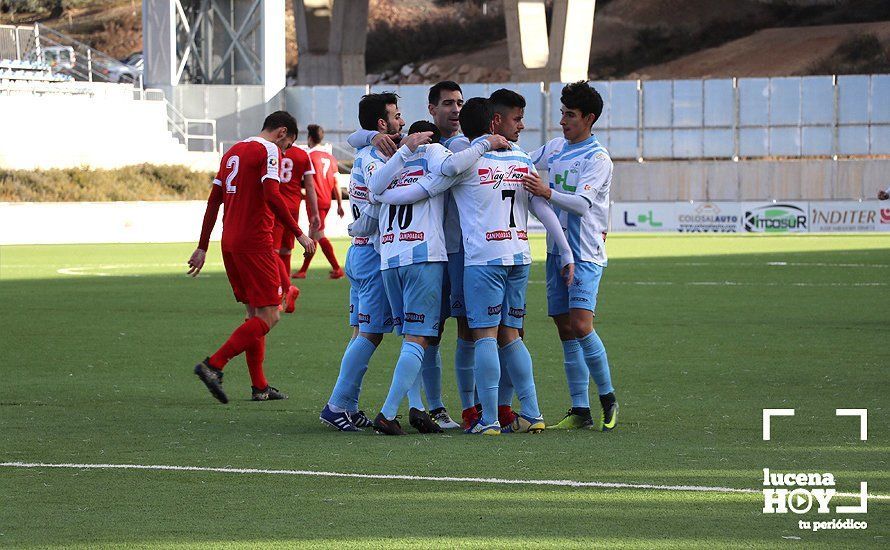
[0,462,890,500]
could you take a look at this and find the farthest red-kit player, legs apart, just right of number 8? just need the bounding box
[294,124,345,279]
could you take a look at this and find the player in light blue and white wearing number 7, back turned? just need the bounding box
[372,98,574,435]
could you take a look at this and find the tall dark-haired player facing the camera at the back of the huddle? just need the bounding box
[347,80,478,429]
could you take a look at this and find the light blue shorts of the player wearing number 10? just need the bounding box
[382,262,445,337]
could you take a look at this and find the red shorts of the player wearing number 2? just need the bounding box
[223,250,283,307]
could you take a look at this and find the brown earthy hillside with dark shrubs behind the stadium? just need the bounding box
[0,0,890,84]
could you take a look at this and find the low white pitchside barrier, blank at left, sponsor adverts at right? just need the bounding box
[0,201,890,245]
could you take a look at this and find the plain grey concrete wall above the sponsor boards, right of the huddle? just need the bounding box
[611,159,890,201]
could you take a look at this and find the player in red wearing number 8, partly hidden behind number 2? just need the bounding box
[272,134,319,313]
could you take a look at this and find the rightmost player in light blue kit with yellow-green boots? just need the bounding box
[524,81,618,431]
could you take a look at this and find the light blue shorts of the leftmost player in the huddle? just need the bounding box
[345,246,393,334]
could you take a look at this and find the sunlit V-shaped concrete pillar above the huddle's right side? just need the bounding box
[504,0,596,82]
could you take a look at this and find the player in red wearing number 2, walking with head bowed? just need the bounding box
[188,111,315,403]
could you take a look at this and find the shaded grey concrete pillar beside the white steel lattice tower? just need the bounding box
[294,0,368,86]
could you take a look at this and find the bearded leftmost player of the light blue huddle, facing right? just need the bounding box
[319,93,405,432]
